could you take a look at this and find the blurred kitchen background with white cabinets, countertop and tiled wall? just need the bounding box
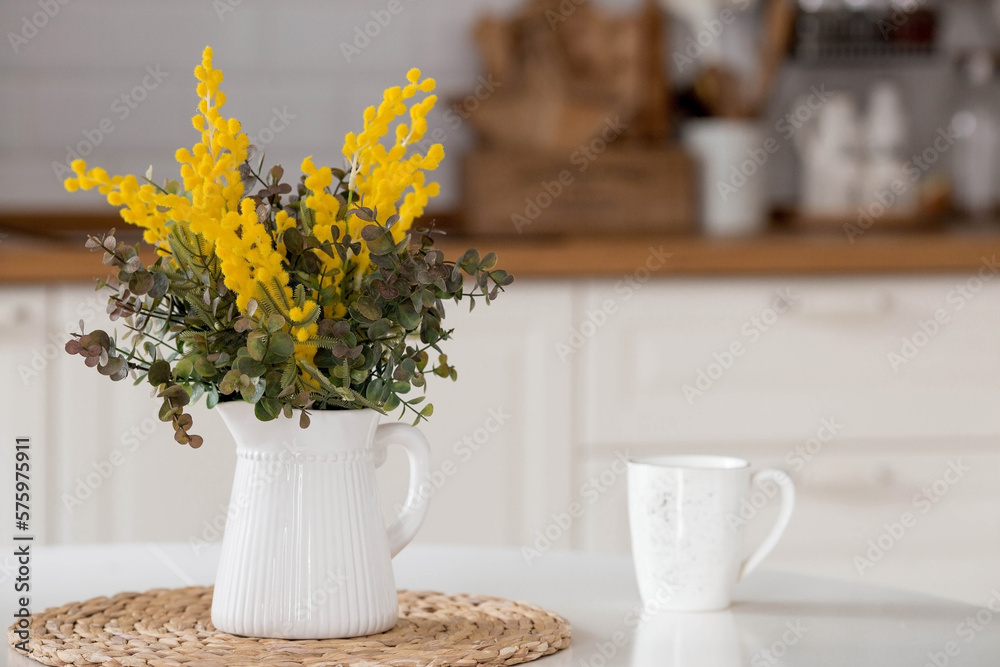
[0,0,1000,604]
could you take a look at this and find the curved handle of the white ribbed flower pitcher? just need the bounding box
[375,424,431,557]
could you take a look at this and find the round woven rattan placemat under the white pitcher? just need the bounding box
[7,586,570,667]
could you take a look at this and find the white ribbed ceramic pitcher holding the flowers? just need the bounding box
[212,402,430,639]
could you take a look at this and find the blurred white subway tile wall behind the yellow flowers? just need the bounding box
[0,0,636,210]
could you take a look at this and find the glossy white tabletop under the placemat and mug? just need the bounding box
[0,544,1000,667]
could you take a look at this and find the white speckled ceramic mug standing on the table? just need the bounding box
[628,456,795,611]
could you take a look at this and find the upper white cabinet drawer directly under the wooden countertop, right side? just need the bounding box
[576,275,1000,446]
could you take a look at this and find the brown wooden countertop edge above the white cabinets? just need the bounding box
[0,214,1000,283]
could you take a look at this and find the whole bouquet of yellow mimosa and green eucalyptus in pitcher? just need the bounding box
[65,48,513,447]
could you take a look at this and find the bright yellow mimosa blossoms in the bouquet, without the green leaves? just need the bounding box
[64,47,444,396]
